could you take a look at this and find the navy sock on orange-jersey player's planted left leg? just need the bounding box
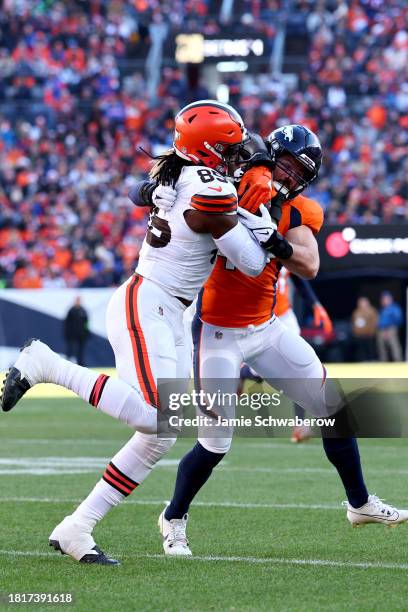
[164,442,225,521]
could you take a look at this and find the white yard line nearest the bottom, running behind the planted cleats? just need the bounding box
[0,550,408,571]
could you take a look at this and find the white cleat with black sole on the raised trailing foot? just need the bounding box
[0,338,58,412]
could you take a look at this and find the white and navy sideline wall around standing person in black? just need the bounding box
[0,288,115,370]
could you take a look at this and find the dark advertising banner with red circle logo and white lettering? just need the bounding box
[317,224,408,272]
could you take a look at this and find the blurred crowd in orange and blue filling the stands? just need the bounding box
[0,0,408,287]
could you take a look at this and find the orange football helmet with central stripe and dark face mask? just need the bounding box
[173,100,246,174]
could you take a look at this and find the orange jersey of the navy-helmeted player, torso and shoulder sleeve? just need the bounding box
[199,195,323,327]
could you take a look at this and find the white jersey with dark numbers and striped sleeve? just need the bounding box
[136,166,237,300]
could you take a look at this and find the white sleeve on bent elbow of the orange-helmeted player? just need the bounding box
[214,223,268,276]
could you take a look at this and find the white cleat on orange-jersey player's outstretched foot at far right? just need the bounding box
[343,495,408,527]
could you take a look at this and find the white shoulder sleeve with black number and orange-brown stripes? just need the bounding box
[191,169,238,214]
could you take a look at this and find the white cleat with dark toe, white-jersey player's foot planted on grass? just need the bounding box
[48,516,120,565]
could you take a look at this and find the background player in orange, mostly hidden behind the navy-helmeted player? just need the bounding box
[238,267,333,443]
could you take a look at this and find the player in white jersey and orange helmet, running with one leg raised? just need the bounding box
[1,100,276,564]
